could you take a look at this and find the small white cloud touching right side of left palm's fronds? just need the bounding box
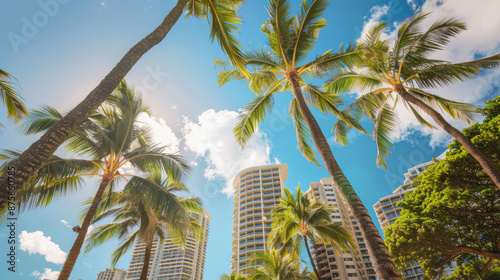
[138,114,181,153]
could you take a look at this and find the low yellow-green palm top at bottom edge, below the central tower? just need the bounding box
[248,250,314,280]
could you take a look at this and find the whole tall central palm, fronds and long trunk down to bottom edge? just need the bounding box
[217,0,400,279]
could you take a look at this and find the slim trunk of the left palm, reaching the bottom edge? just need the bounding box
[57,176,111,280]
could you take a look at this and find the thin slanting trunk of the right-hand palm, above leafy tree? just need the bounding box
[394,85,500,189]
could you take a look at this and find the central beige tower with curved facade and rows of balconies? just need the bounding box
[231,164,288,275]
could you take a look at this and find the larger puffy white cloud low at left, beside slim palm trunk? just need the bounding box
[19,230,67,264]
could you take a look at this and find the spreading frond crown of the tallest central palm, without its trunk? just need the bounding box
[215,0,366,166]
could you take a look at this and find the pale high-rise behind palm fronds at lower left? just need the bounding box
[127,211,211,280]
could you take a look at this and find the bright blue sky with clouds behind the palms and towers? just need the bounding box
[0,0,500,279]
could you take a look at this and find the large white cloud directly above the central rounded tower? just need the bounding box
[182,109,277,195]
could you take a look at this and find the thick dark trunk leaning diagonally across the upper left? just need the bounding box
[0,0,188,209]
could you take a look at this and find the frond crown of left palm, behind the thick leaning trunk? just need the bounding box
[0,81,189,219]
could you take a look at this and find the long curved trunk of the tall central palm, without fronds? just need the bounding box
[289,71,401,280]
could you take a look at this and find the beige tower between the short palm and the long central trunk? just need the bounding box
[308,178,377,280]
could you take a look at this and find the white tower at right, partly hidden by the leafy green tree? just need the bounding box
[373,153,445,280]
